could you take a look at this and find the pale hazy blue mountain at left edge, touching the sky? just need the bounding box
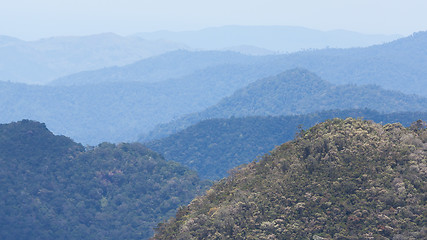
[0,33,186,84]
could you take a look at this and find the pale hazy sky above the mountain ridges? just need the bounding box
[0,0,427,40]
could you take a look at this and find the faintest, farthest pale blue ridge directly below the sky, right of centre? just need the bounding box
[137,26,400,52]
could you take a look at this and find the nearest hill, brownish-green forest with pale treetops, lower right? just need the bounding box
[153,118,427,239]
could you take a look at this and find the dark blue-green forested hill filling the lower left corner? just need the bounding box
[0,120,209,240]
